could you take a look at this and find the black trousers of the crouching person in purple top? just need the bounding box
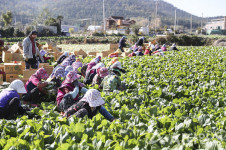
[0,97,23,119]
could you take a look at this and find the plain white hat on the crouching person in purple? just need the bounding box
[6,80,27,93]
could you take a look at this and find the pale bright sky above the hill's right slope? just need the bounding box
[164,0,226,17]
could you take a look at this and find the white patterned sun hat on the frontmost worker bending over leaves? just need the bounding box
[81,89,105,107]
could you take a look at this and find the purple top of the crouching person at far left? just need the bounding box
[0,90,20,108]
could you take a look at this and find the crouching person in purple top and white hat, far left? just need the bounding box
[0,80,27,119]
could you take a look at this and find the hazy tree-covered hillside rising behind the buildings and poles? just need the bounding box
[0,0,222,28]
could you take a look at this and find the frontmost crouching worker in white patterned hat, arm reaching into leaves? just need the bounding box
[64,89,114,122]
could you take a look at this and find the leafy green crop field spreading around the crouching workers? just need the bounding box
[0,47,226,150]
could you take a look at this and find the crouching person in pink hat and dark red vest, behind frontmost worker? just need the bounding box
[56,71,87,112]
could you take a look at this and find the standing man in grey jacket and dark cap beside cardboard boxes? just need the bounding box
[23,31,44,69]
